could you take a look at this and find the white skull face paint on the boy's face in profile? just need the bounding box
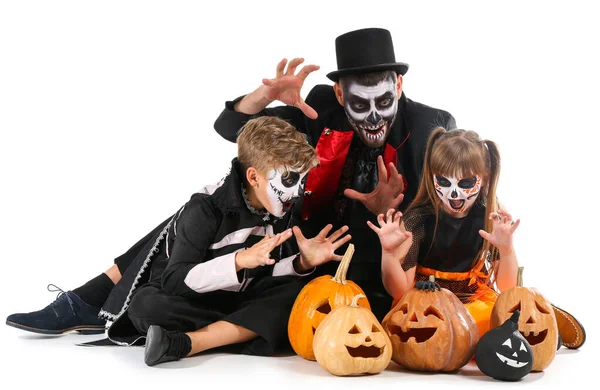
[265,169,308,217]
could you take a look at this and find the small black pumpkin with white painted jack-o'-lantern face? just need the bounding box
[475,310,533,381]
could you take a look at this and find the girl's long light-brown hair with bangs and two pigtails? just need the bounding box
[407,127,500,263]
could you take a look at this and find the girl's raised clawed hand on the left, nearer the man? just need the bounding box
[367,209,412,257]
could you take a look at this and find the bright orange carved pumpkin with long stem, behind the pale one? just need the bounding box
[288,244,371,360]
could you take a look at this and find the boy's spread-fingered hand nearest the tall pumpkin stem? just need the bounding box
[293,224,352,269]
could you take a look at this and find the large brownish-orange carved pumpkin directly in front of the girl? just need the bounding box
[383,276,479,371]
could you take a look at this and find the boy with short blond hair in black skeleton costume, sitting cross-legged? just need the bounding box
[101,117,350,366]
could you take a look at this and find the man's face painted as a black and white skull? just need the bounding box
[344,77,398,148]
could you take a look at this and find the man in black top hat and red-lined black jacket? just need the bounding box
[215,28,456,320]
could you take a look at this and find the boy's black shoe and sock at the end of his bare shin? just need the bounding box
[144,325,191,366]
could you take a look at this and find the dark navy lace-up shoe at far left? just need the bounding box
[6,284,106,334]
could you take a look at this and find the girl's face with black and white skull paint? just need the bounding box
[433,175,481,217]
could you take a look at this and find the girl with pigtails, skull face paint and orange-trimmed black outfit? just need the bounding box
[368,128,520,334]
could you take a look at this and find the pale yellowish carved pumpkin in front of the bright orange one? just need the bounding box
[313,294,392,376]
